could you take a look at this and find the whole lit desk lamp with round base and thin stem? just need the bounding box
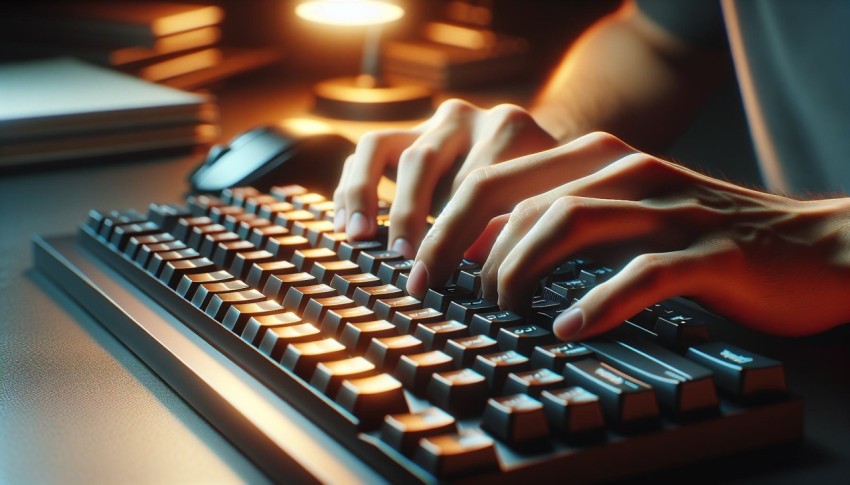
[295,0,432,121]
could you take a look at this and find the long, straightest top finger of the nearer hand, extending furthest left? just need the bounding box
[407,134,633,295]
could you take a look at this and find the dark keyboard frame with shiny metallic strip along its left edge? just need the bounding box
[33,227,803,483]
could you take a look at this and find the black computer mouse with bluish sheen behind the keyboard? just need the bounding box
[189,120,354,196]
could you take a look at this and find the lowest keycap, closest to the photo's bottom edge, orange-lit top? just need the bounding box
[414,429,499,478]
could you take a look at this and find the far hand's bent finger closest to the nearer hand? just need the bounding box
[389,121,470,258]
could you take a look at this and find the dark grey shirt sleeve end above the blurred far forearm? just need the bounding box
[636,0,727,49]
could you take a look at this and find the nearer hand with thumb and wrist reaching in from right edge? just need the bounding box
[408,133,850,339]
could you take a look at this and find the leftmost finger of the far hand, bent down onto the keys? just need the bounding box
[341,130,419,240]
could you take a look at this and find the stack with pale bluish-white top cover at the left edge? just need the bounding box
[0,58,218,173]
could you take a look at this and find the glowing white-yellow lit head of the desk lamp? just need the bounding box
[295,0,404,26]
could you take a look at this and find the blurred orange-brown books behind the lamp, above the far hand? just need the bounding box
[383,22,528,89]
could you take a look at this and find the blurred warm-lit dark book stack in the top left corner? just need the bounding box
[0,1,279,89]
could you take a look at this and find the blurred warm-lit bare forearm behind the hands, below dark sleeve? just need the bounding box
[532,3,731,149]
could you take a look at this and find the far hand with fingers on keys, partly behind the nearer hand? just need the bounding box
[334,100,556,258]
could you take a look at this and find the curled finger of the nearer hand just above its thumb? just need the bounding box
[496,196,668,310]
